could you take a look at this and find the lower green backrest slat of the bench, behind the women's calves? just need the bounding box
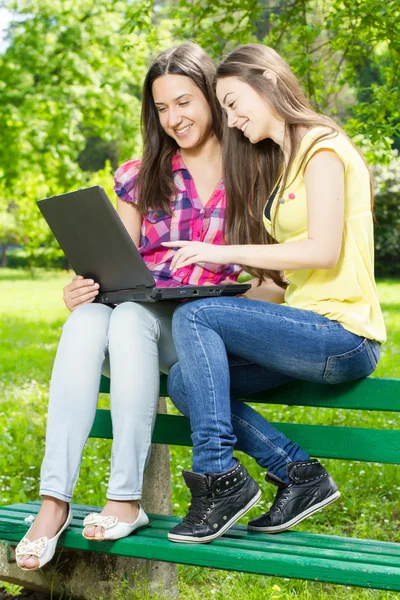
[90,410,400,464]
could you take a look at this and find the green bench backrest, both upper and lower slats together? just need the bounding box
[90,375,400,464]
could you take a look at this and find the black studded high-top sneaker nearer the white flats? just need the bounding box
[168,460,261,544]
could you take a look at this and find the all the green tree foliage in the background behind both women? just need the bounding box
[0,0,400,273]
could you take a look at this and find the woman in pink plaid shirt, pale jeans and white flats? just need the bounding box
[16,43,240,570]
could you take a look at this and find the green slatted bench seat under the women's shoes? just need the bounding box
[0,503,400,591]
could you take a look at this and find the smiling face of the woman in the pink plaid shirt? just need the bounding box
[152,75,216,148]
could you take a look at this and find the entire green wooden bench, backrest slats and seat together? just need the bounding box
[0,377,400,591]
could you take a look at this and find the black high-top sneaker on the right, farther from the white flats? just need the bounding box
[247,460,340,533]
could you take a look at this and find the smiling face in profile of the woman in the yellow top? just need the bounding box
[217,77,283,144]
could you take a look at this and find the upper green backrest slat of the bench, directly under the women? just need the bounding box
[100,375,400,412]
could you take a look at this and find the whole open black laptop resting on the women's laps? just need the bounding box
[37,186,251,304]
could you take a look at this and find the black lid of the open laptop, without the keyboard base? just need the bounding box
[37,186,155,292]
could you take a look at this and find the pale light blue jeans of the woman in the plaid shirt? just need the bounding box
[40,302,177,502]
